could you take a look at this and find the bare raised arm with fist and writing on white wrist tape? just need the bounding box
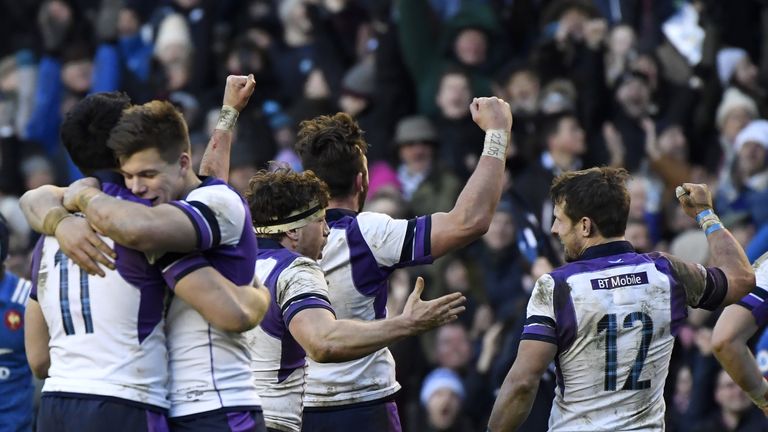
[430,97,512,258]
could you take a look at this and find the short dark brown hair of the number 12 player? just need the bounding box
[550,167,629,237]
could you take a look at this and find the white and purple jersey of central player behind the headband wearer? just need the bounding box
[304,209,432,408]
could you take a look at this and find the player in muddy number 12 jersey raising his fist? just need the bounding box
[488,168,755,432]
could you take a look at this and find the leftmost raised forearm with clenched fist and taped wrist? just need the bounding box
[200,75,256,181]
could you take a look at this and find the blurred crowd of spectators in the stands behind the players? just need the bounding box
[0,0,768,432]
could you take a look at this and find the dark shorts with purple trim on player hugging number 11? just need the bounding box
[168,408,267,432]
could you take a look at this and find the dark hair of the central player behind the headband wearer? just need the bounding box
[296,112,368,198]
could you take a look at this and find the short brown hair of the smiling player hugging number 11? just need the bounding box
[107,100,190,163]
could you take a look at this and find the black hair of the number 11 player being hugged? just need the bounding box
[60,92,131,174]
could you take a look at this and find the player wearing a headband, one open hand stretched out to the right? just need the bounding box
[246,169,464,432]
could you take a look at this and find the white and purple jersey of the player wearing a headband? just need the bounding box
[245,238,333,432]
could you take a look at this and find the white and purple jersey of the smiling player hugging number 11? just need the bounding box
[159,177,260,417]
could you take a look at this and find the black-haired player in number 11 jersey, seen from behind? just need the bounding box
[22,77,266,431]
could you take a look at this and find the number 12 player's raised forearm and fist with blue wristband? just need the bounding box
[676,183,755,305]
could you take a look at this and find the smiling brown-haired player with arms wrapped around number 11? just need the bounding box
[54,96,267,431]
